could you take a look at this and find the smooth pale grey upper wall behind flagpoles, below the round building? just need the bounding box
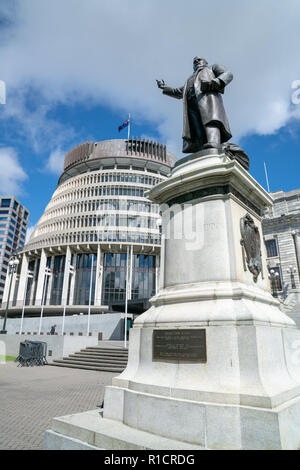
[0,313,124,340]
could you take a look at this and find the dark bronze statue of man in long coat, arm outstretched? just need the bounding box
[157,57,233,153]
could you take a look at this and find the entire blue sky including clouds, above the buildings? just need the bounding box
[0,0,300,235]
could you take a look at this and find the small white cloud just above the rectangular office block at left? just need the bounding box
[0,147,27,196]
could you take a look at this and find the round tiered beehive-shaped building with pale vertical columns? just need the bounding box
[2,139,176,316]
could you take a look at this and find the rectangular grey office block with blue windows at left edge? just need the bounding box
[0,196,29,304]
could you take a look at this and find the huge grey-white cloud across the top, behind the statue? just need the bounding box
[0,0,300,155]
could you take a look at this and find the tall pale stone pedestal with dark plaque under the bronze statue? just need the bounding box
[44,150,300,449]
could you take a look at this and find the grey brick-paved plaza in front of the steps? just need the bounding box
[0,363,117,450]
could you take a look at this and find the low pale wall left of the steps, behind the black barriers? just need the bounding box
[0,334,98,361]
